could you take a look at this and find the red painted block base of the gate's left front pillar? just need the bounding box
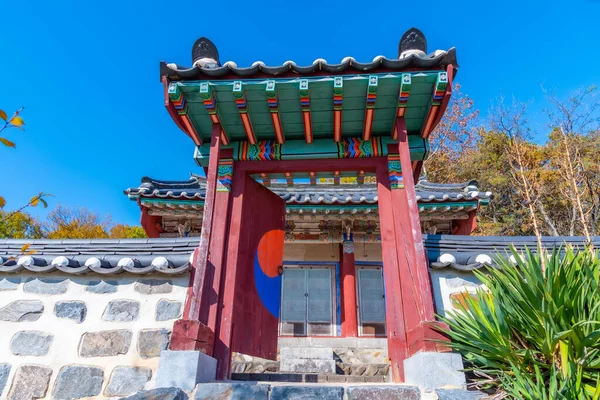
[169,319,215,356]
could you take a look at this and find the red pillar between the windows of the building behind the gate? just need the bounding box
[340,234,358,337]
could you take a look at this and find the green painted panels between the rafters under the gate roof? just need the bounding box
[177,71,439,142]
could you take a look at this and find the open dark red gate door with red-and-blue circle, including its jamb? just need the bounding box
[215,170,285,377]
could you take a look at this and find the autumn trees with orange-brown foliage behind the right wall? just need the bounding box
[426,83,600,236]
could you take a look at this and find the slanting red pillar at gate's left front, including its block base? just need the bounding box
[169,124,221,355]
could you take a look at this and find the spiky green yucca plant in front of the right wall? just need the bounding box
[440,248,600,400]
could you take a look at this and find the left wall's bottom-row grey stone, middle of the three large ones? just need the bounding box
[52,365,104,400]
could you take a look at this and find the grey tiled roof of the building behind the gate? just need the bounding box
[124,175,492,205]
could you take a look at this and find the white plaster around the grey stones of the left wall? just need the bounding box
[0,273,189,399]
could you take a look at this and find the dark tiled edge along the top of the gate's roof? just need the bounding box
[160,48,458,80]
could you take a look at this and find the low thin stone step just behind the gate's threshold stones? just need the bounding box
[231,373,387,383]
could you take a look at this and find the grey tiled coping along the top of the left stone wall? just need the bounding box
[0,238,198,275]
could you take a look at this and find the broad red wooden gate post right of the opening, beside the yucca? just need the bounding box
[377,117,443,382]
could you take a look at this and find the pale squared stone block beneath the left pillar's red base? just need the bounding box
[156,350,217,390]
